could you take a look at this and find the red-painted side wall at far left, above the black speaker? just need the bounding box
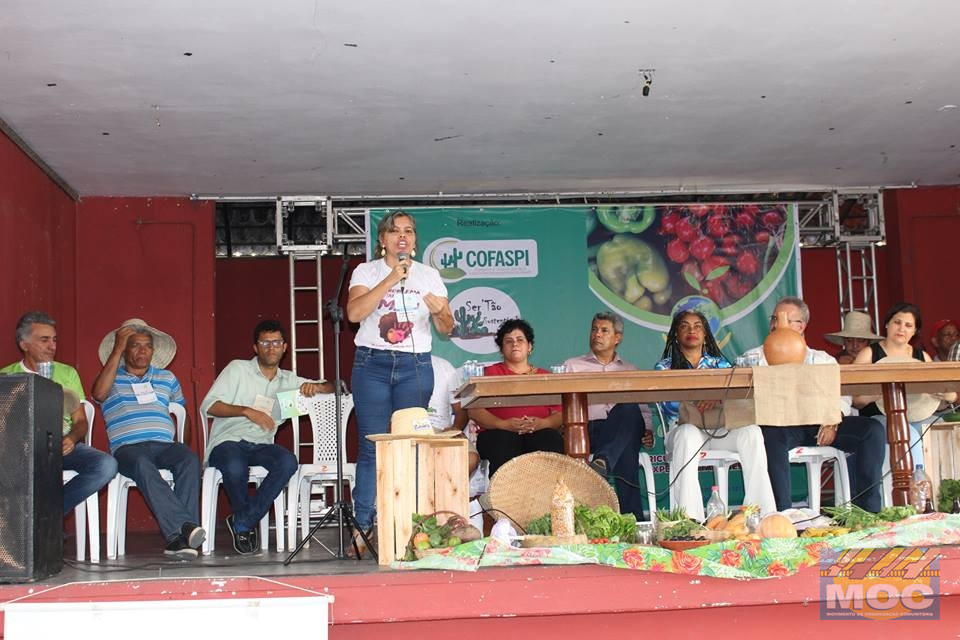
[0,133,78,364]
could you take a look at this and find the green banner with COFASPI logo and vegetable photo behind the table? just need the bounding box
[368,204,800,369]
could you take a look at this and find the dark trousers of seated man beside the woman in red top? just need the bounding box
[587,403,647,520]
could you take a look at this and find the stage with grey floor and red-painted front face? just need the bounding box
[0,526,960,640]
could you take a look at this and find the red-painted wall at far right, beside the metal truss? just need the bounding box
[881,186,960,352]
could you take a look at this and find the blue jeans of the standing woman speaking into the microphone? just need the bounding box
[350,347,433,529]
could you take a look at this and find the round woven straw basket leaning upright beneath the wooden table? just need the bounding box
[490,451,620,529]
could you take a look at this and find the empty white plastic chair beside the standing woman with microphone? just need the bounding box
[287,393,357,548]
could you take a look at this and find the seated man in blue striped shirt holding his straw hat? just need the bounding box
[93,318,206,560]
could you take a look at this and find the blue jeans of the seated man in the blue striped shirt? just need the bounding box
[113,440,201,542]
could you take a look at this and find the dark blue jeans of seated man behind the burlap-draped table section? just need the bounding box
[760,416,887,513]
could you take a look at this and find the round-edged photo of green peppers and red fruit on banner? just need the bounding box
[587,204,796,355]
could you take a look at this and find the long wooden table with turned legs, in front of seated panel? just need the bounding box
[458,362,960,505]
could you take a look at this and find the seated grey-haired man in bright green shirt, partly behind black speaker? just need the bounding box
[0,311,117,515]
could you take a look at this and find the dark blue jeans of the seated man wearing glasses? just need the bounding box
[210,440,299,533]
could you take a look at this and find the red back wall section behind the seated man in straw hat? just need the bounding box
[76,198,216,539]
